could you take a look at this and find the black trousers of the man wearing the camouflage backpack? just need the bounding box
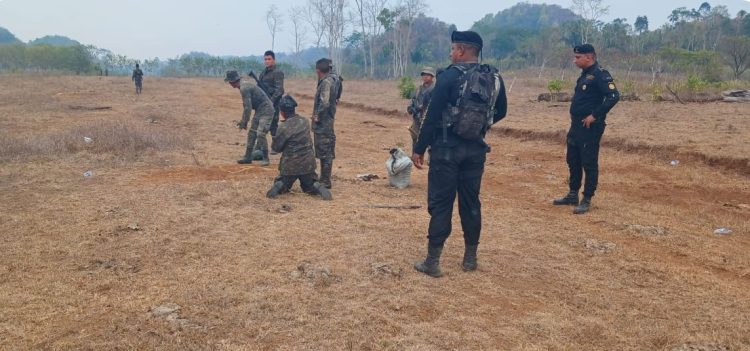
[427,141,487,247]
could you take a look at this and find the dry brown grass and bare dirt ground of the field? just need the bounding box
[0,76,750,350]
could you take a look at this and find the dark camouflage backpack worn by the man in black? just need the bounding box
[443,65,501,140]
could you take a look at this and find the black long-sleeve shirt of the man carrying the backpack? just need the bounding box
[414,63,508,155]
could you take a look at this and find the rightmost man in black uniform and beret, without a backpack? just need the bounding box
[552,44,620,214]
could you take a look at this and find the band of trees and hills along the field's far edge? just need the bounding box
[0,0,750,83]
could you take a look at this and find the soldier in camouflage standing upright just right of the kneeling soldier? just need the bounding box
[312,58,341,189]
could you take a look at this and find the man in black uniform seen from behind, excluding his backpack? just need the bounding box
[412,31,507,277]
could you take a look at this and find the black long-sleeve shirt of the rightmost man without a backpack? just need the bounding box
[570,62,620,122]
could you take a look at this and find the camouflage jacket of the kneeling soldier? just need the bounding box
[271,114,315,176]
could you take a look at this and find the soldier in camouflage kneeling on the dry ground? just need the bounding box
[266,95,332,200]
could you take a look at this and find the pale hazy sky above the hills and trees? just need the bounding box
[0,0,750,59]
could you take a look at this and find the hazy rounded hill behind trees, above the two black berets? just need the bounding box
[472,2,578,32]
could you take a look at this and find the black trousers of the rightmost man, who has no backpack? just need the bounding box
[566,121,606,197]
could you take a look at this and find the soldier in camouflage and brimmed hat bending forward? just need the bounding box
[224,71,273,166]
